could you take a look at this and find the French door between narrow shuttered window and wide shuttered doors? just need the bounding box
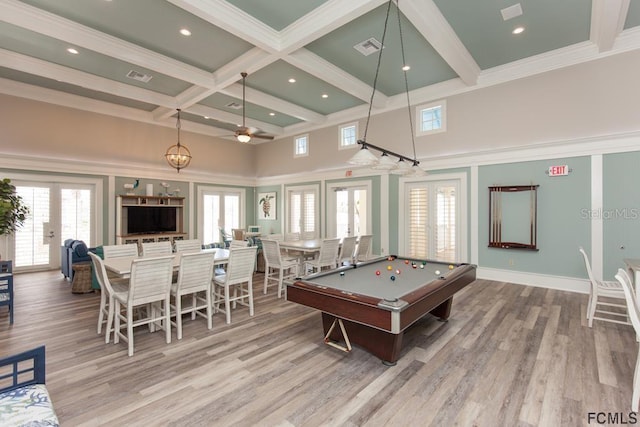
[327,182,371,237]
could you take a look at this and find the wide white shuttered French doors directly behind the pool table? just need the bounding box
[401,176,466,262]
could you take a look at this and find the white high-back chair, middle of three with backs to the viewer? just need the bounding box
[170,252,215,340]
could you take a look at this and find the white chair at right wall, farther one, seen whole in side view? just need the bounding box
[578,247,629,328]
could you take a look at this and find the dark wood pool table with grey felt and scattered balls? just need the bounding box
[287,256,476,365]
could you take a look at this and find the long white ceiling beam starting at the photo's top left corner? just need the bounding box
[0,0,215,87]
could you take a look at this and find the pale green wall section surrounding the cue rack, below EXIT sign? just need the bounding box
[478,157,591,277]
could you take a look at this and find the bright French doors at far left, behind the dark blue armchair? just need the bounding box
[11,180,98,271]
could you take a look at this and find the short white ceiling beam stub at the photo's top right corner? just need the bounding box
[589,0,630,52]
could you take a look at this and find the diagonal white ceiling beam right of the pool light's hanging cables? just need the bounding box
[399,0,480,86]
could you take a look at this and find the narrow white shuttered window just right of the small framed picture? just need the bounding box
[286,186,320,236]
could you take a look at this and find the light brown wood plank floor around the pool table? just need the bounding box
[0,272,638,427]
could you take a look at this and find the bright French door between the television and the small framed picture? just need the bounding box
[198,187,245,244]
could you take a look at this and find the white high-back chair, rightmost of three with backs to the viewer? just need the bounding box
[212,246,258,324]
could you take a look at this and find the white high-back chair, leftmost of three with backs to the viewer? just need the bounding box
[113,255,173,356]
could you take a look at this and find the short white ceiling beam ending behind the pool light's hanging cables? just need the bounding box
[284,48,388,108]
